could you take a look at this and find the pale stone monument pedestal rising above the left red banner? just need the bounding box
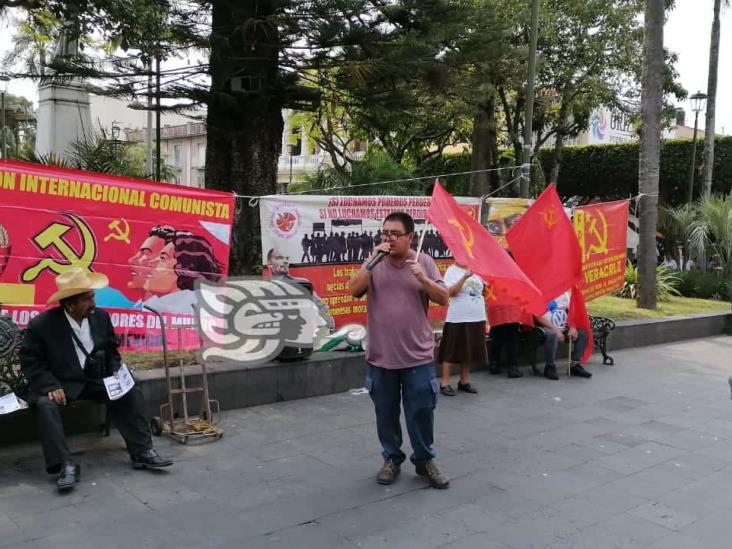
[36,82,93,157]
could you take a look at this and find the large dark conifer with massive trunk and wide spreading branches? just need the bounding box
[2,0,464,274]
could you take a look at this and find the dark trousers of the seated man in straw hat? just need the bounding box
[36,382,152,473]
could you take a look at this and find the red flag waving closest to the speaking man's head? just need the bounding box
[427,181,546,315]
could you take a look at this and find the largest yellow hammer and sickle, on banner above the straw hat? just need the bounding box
[22,214,96,282]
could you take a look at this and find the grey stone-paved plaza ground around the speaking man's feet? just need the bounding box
[0,337,732,549]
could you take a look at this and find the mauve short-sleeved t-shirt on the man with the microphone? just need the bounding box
[366,252,444,370]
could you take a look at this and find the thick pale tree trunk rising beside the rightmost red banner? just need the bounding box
[638,0,664,309]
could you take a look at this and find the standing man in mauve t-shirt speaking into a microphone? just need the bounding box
[349,212,450,488]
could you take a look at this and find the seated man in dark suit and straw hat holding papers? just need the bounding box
[20,269,173,490]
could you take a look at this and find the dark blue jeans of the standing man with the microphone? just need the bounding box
[366,362,437,463]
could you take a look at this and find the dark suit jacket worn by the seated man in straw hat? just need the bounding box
[20,307,121,402]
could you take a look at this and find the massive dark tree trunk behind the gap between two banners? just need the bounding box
[206,0,284,275]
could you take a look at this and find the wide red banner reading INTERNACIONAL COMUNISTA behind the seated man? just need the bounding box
[0,161,234,347]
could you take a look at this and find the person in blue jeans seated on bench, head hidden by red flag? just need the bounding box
[536,291,592,380]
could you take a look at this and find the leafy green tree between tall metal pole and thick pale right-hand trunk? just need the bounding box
[535,0,643,181]
